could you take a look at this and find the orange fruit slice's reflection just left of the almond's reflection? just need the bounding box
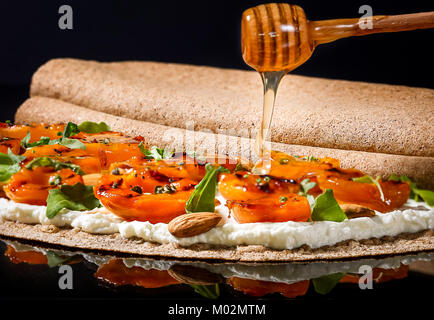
[95,259,179,288]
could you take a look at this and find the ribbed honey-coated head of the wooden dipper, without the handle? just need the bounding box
[241,3,314,72]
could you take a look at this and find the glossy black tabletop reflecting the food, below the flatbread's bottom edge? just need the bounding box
[0,239,434,303]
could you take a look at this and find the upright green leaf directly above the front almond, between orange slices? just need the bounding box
[185,163,229,213]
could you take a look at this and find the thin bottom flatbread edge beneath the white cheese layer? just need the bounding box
[0,220,434,262]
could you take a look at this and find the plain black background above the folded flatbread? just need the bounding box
[0,0,434,120]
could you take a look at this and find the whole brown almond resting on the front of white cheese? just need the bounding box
[168,212,222,238]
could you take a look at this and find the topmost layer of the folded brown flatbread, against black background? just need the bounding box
[31,59,434,158]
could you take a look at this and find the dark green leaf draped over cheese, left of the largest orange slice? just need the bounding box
[45,183,101,219]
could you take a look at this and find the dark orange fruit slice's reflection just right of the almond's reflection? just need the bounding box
[227,277,309,298]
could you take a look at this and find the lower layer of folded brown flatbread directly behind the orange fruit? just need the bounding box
[15,97,434,188]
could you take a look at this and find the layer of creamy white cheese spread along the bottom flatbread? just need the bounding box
[0,198,434,249]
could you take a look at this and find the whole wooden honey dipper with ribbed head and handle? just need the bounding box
[241,3,434,72]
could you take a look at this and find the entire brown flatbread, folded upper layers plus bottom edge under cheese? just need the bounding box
[7,59,434,262]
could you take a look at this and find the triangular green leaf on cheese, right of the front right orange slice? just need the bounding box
[311,189,348,222]
